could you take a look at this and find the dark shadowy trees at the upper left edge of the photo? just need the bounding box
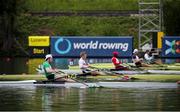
[0,0,25,56]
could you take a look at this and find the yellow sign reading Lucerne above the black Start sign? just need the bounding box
[28,36,50,46]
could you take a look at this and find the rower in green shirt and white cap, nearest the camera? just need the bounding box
[42,54,72,82]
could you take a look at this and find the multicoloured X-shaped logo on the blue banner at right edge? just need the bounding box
[165,40,180,55]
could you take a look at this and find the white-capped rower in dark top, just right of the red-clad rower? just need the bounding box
[132,49,150,67]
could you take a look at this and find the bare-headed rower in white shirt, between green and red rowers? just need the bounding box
[79,51,98,75]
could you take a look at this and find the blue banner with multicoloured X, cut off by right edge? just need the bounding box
[162,36,180,58]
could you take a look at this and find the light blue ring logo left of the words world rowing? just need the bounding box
[54,38,71,54]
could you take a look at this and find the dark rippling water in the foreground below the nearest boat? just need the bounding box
[0,85,180,111]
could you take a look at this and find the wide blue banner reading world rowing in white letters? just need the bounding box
[50,36,133,57]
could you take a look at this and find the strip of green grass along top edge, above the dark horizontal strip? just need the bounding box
[26,0,138,11]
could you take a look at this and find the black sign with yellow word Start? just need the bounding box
[29,47,49,57]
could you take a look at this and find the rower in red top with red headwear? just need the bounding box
[111,52,128,70]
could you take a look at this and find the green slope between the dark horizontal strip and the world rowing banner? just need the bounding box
[19,16,138,37]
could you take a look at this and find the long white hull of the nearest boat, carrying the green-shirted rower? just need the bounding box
[0,80,178,88]
